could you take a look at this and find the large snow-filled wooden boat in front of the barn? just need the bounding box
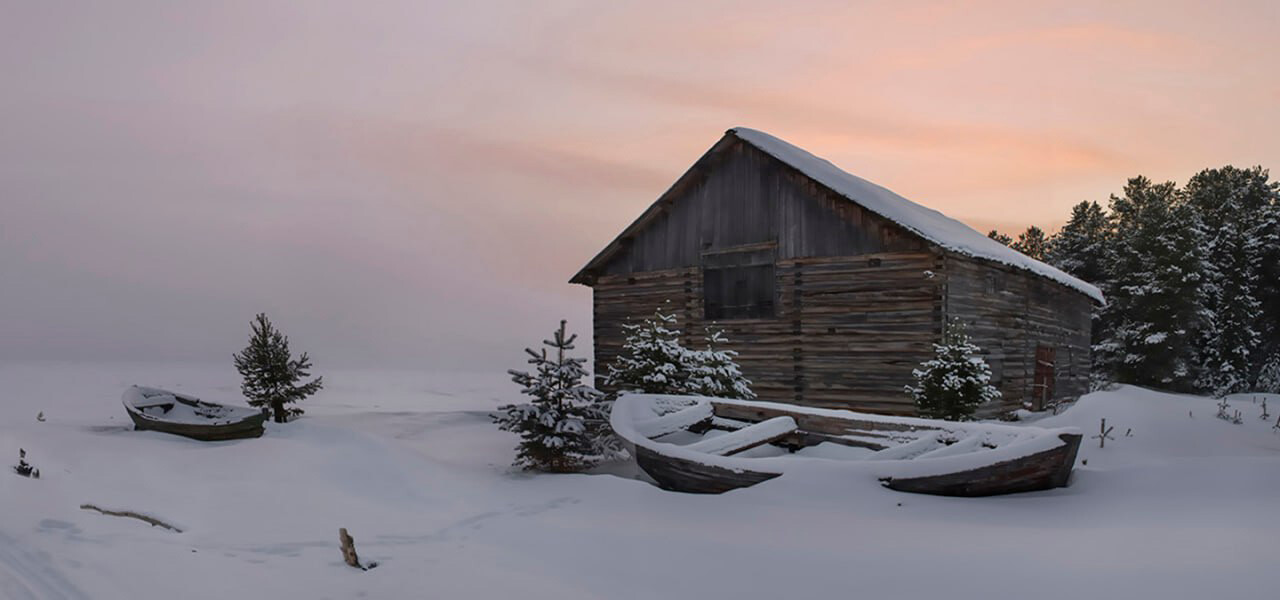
[611,394,1082,496]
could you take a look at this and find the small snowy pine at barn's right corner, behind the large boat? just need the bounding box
[906,320,1001,421]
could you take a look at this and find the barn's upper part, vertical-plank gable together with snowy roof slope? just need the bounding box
[570,127,1103,302]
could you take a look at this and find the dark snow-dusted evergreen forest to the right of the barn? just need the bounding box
[988,166,1280,397]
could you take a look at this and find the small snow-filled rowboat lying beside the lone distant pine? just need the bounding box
[123,385,266,441]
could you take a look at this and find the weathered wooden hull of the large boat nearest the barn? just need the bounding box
[611,394,1083,496]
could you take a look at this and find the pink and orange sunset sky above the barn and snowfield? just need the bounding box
[0,1,1280,368]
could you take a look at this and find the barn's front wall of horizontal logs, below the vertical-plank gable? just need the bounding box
[594,252,945,414]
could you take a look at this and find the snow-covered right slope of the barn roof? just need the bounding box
[728,127,1103,302]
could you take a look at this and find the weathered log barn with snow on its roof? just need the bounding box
[571,128,1102,414]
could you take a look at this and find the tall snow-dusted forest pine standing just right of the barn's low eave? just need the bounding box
[1094,177,1204,390]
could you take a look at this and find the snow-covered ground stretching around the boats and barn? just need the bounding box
[0,365,1280,599]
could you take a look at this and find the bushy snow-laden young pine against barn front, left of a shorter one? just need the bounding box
[604,308,690,394]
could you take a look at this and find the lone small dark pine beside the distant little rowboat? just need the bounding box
[233,312,324,423]
